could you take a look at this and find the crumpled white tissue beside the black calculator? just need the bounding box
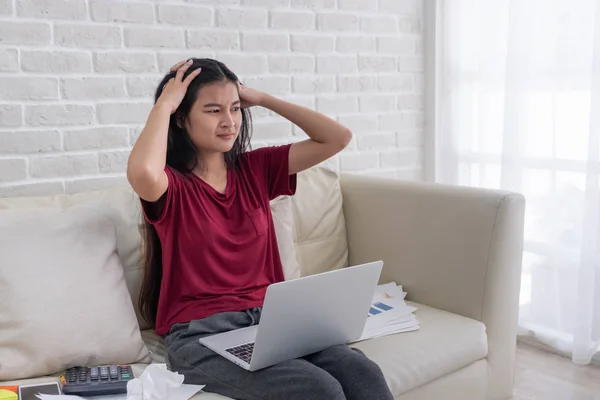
[127,364,204,400]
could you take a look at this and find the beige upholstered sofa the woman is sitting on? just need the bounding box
[0,171,524,400]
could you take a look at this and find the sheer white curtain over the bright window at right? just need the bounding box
[435,0,600,364]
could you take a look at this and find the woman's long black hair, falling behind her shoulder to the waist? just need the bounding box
[138,58,252,325]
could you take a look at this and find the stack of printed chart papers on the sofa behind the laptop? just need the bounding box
[357,282,419,341]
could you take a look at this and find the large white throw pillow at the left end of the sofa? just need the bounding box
[0,206,150,381]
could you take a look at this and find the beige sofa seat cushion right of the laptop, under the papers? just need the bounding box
[352,302,487,396]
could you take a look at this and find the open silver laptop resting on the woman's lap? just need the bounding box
[200,261,383,371]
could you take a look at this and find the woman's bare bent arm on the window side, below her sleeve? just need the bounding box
[240,86,352,175]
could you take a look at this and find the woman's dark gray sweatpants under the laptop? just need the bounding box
[165,307,394,400]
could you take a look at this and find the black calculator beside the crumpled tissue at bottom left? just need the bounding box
[60,365,134,397]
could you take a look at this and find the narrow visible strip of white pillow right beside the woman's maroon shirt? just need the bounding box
[271,196,302,280]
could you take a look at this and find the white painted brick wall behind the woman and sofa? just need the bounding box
[0,0,424,196]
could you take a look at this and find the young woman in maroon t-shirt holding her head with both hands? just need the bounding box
[127,59,393,400]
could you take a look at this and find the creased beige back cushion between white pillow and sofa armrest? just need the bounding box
[292,167,348,276]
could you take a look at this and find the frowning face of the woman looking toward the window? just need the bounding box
[185,81,242,153]
